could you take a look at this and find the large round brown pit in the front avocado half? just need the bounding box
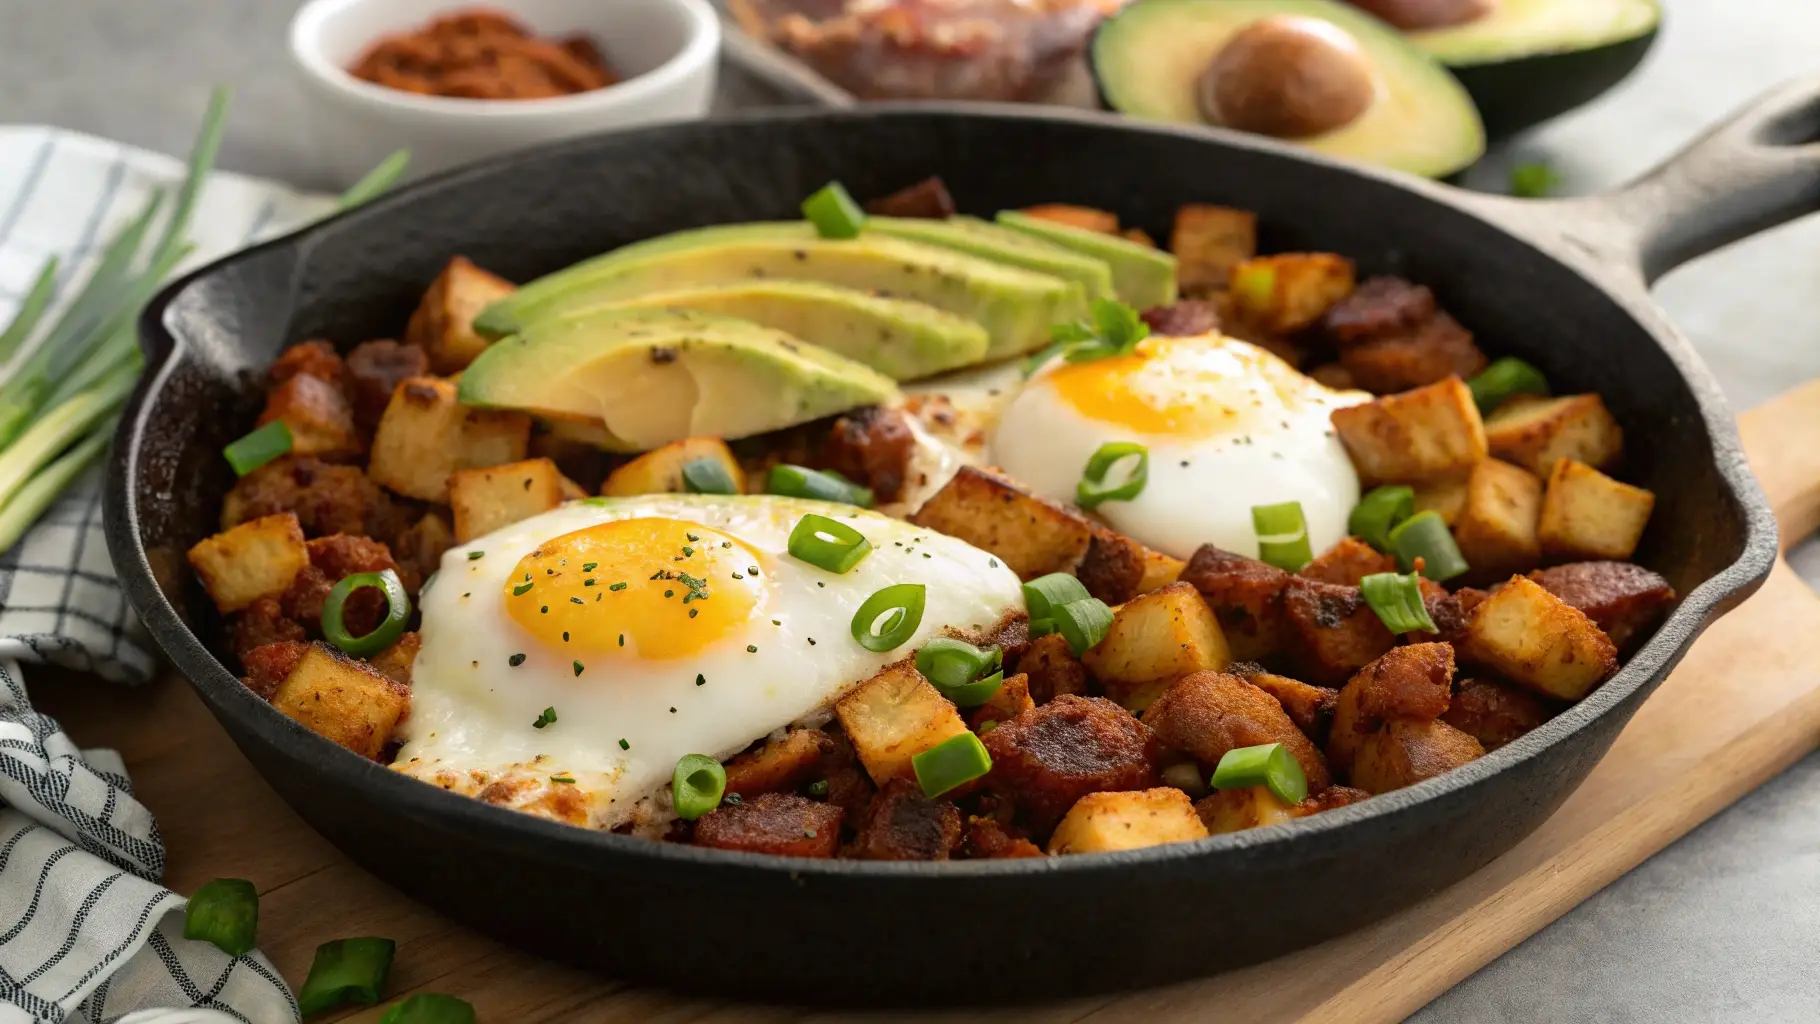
[1196,15,1376,138]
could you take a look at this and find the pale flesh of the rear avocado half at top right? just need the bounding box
[1409,0,1662,67]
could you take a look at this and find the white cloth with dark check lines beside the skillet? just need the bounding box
[0,127,331,1024]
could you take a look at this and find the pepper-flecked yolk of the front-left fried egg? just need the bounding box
[504,518,766,660]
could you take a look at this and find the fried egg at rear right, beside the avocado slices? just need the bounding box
[990,335,1370,558]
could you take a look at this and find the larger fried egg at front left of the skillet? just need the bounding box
[393,495,1023,828]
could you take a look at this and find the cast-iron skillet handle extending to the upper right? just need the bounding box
[1481,76,1820,287]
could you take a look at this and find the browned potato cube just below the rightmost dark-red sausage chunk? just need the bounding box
[1463,577,1618,704]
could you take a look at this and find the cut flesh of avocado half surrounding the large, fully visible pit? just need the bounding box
[1092,0,1485,178]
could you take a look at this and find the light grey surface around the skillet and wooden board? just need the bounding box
[0,0,1820,1024]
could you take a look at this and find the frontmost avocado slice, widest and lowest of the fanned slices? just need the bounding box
[457,309,897,451]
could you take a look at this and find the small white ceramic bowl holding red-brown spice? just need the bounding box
[291,0,721,186]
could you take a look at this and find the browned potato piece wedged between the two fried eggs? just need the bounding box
[910,466,1094,580]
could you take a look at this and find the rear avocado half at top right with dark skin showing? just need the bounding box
[1409,0,1662,138]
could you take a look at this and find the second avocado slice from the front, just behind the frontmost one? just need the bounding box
[575,278,992,380]
